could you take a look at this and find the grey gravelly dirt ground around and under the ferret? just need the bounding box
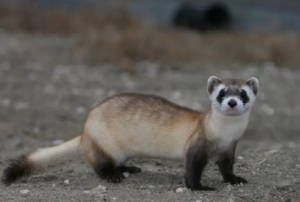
[0,32,300,202]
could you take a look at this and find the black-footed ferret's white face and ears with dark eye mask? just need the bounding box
[207,76,259,116]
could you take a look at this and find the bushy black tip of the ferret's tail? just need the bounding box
[2,155,34,186]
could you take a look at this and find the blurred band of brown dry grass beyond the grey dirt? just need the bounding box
[0,4,300,67]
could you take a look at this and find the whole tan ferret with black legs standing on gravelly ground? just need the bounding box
[2,76,259,191]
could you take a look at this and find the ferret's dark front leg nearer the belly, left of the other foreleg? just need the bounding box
[185,140,215,191]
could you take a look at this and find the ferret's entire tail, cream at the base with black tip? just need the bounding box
[2,136,81,186]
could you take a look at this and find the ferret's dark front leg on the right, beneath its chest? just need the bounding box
[217,142,247,184]
